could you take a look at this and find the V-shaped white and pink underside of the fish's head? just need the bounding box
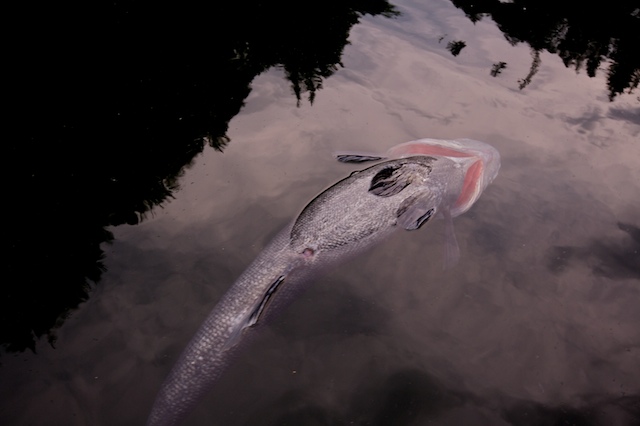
[386,139,500,217]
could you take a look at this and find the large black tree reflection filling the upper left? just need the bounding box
[0,0,395,351]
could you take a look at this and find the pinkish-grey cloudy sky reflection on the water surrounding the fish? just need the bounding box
[0,0,640,426]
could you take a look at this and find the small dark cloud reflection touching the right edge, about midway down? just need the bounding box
[547,222,640,280]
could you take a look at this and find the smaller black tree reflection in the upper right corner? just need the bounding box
[451,0,640,100]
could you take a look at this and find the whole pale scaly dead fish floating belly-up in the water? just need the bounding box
[147,139,500,426]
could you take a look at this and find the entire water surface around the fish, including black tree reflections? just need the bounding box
[0,0,640,426]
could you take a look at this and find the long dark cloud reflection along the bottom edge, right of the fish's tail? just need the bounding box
[243,368,640,426]
